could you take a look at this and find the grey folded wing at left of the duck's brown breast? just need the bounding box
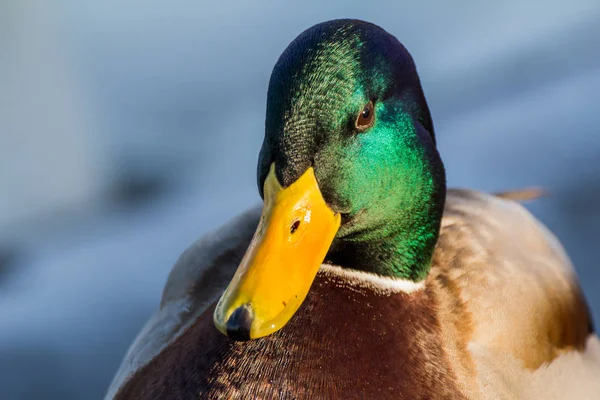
[105,207,261,399]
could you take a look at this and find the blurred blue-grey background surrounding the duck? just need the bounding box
[0,0,600,400]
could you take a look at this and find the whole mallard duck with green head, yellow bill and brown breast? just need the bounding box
[107,20,600,400]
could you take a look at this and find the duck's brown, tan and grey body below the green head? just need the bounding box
[107,190,600,400]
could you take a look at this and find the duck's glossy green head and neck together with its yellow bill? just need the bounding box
[214,20,446,340]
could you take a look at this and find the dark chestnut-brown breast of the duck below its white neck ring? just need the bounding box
[117,275,462,399]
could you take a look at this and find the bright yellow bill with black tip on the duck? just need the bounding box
[214,164,340,340]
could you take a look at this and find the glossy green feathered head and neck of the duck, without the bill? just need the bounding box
[258,20,446,280]
